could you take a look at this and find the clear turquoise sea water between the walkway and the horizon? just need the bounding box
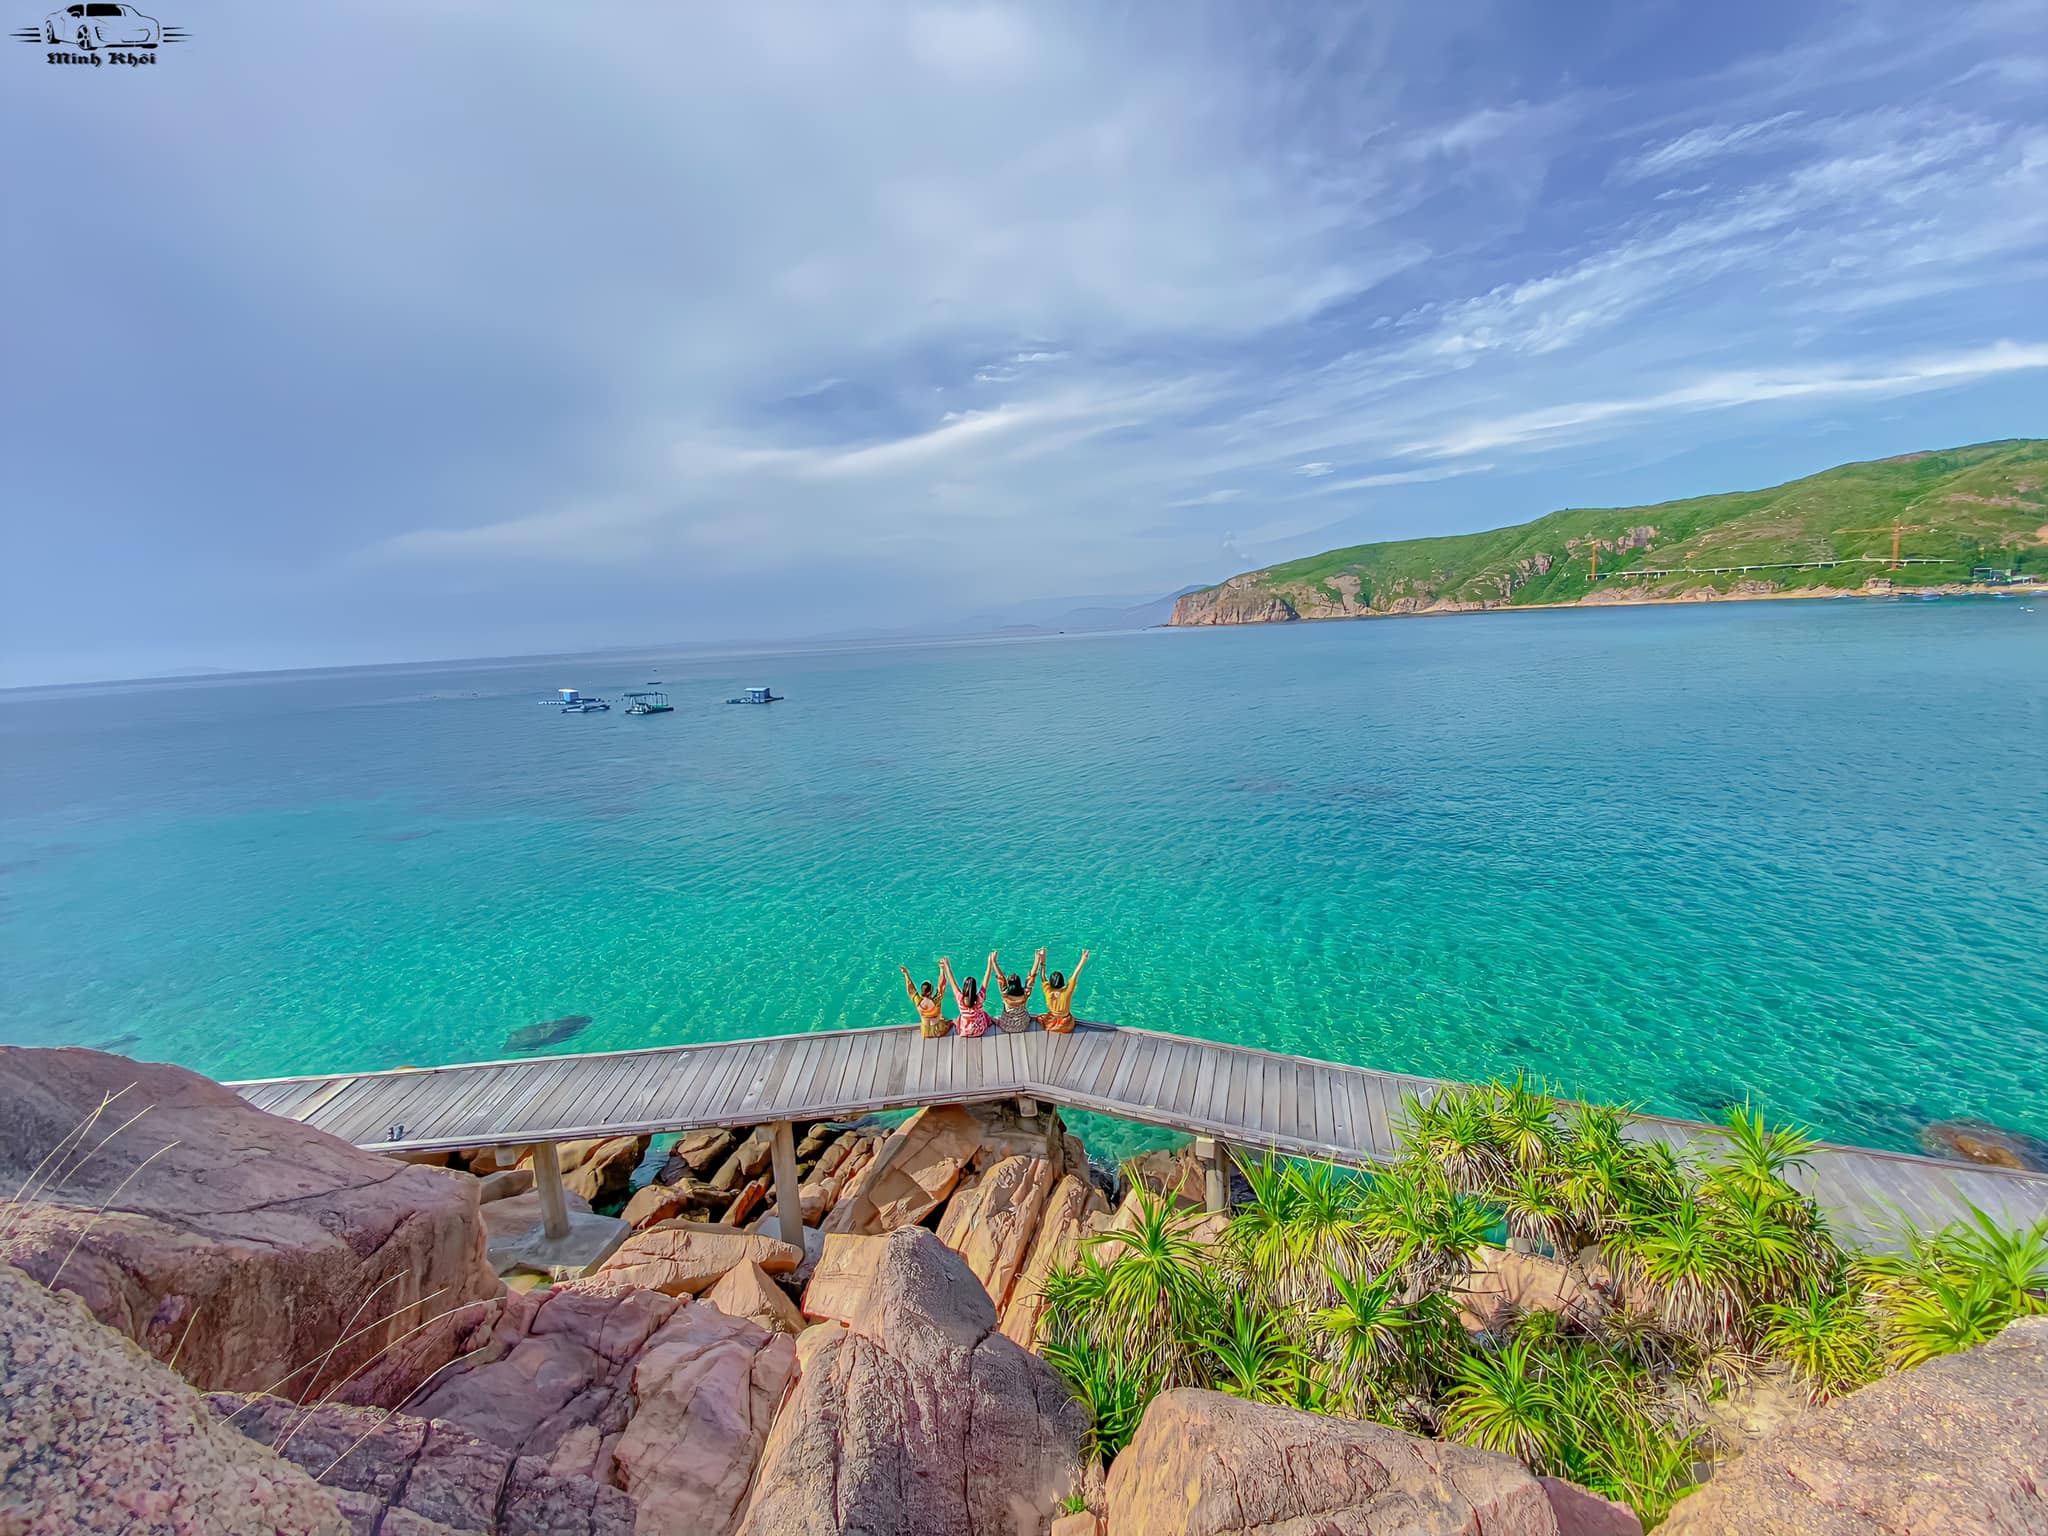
[0,602,2048,1147]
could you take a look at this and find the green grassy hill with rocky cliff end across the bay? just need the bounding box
[1171,438,2048,625]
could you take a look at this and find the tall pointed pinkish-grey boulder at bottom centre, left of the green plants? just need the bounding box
[739,1227,1085,1536]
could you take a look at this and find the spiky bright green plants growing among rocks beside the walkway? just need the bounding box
[1040,1077,2048,1524]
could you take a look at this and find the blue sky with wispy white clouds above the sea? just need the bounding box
[0,0,2048,684]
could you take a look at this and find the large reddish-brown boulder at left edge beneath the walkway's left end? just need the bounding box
[0,1047,500,1401]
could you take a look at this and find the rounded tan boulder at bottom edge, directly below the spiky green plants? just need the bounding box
[1108,1389,1559,1536]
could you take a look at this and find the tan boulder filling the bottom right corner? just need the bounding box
[1657,1317,2048,1536]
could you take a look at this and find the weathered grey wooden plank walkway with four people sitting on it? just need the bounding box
[233,1024,2048,1247]
